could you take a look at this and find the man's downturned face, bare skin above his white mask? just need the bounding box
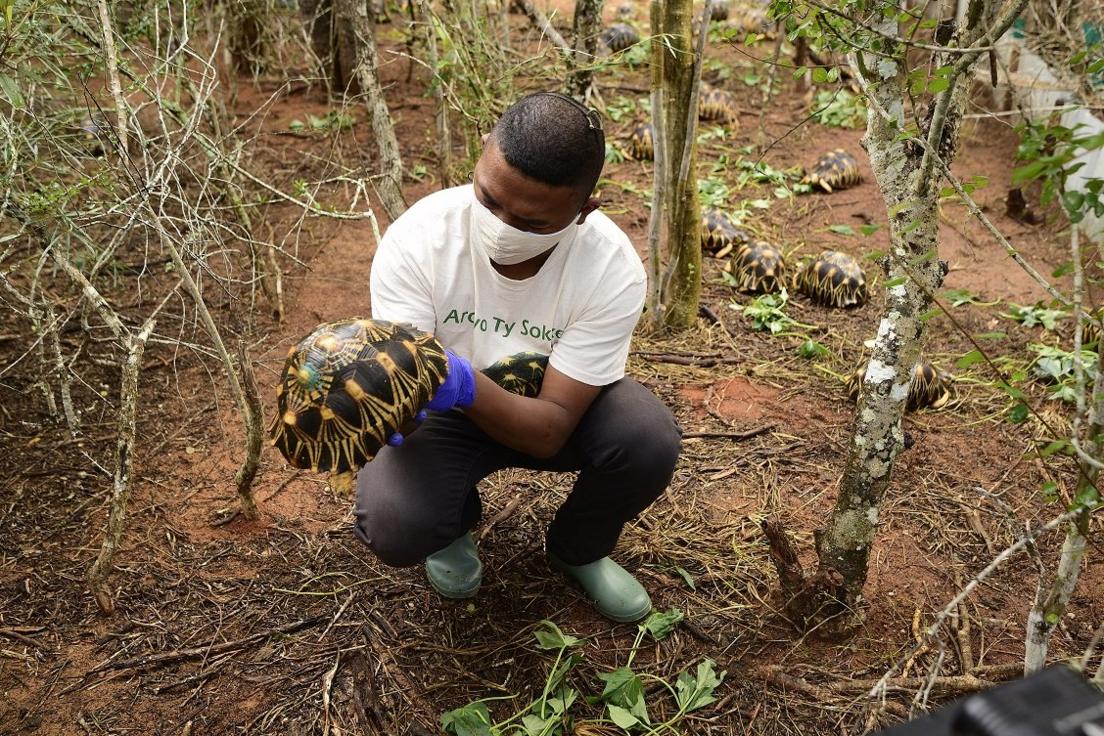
[475,139,594,233]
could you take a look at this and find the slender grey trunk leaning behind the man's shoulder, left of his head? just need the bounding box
[335,0,406,221]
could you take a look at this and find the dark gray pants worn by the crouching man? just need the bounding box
[354,378,681,567]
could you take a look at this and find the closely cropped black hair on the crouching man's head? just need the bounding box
[491,92,606,206]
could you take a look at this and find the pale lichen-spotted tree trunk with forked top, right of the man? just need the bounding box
[779,0,1023,626]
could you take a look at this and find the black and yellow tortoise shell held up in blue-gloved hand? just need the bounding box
[268,319,448,473]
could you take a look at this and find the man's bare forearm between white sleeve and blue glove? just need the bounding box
[464,365,602,458]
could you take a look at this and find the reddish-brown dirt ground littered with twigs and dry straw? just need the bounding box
[0,5,1104,736]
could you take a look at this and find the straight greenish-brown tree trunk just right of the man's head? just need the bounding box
[651,0,701,328]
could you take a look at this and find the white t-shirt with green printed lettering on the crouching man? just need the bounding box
[371,184,647,386]
